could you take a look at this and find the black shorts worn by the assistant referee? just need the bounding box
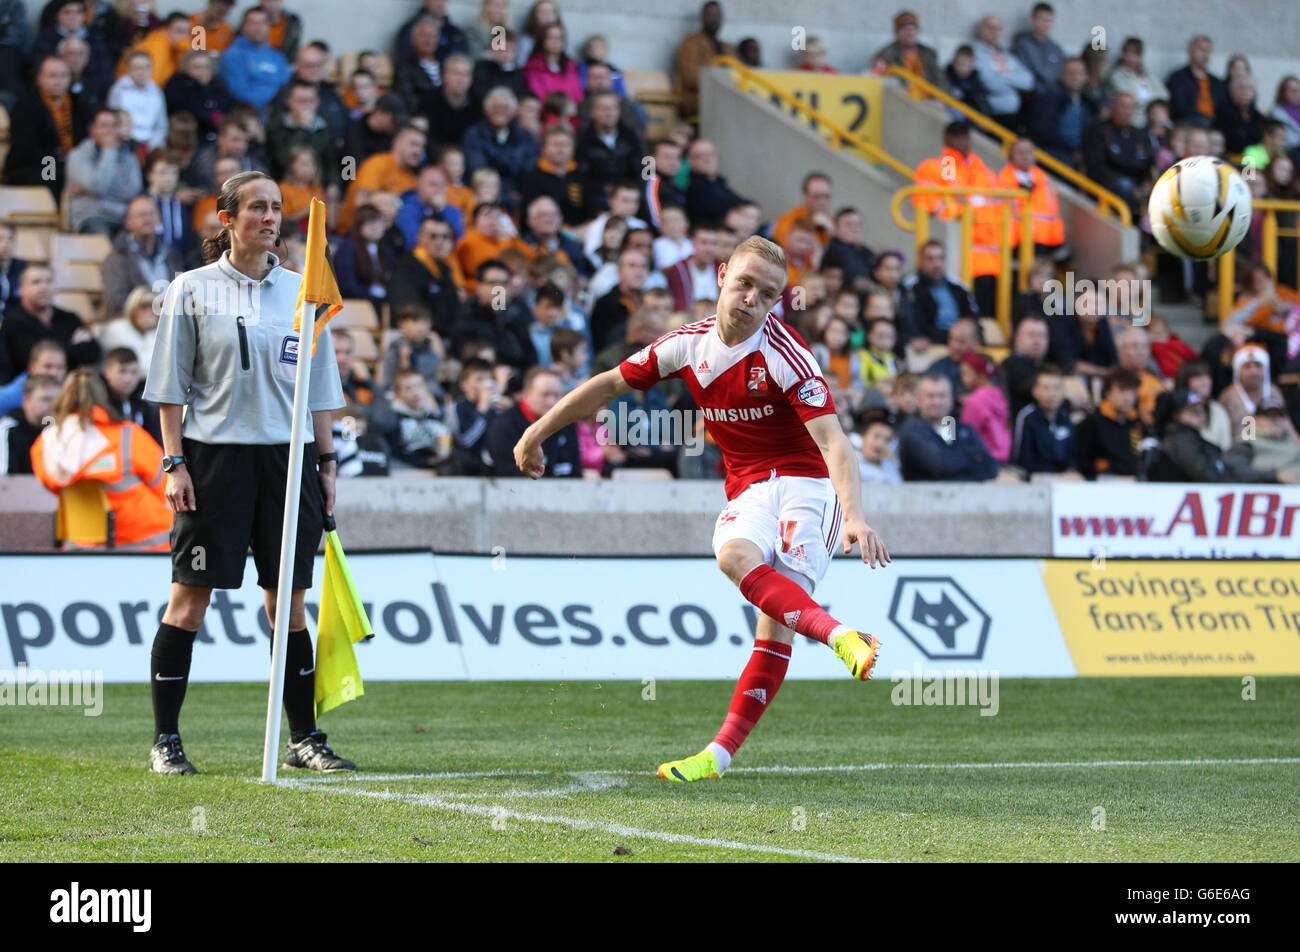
[172,440,325,589]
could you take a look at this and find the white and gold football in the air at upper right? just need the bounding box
[1147,156,1251,261]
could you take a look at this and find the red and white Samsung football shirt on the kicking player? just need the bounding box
[619,313,835,499]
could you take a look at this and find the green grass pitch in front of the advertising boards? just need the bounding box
[0,678,1300,862]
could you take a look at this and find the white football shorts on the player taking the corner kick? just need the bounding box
[714,476,844,587]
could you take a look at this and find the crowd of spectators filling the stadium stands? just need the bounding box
[0,0,1300,538]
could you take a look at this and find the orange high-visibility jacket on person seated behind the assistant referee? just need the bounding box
[31,407,172,551]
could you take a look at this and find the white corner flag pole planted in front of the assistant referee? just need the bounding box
[261,300,316,783]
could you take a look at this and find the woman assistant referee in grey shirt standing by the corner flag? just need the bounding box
[144,172,356,774]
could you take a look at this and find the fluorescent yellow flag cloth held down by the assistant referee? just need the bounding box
[316,528,374,717]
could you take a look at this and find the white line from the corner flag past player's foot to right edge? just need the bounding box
[271,757,1300,784]
